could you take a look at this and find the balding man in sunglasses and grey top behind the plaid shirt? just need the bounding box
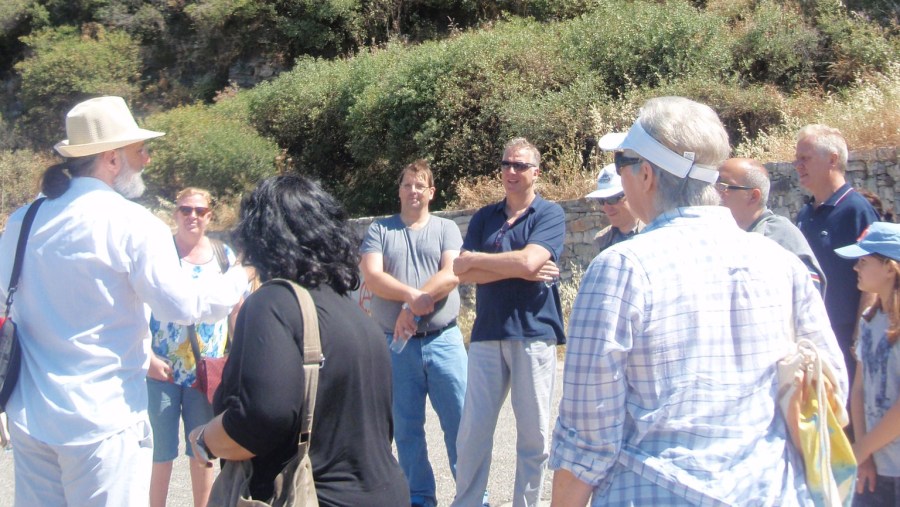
[716,158,826,294]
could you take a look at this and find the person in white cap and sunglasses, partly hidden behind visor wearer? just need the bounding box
[585,164,644,253]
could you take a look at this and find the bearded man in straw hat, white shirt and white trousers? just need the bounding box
[0,97,247,506]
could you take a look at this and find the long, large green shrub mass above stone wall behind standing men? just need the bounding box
[237,2,731,214]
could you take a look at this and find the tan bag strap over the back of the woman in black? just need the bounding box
[267,278,325,453]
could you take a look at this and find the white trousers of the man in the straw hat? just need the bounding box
[9,420,153,507]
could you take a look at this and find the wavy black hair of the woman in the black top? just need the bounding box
[234,174,359,295]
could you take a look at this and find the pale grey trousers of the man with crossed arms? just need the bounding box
[453,339,556,507]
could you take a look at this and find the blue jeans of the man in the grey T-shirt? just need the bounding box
[387,326,468,506]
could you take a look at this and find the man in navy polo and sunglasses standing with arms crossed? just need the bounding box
[453,138,566,507]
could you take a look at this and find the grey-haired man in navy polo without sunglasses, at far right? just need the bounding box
[794,125,878,382]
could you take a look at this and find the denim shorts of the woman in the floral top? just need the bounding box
[147,378,213,463]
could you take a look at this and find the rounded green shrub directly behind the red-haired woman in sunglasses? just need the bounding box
[146,99,279,199]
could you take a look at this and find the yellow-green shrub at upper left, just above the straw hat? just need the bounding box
[16,25,141,147]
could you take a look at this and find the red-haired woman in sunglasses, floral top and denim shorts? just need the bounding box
[147,187,240,507]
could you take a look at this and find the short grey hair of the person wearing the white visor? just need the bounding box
[633,97,731,213]
